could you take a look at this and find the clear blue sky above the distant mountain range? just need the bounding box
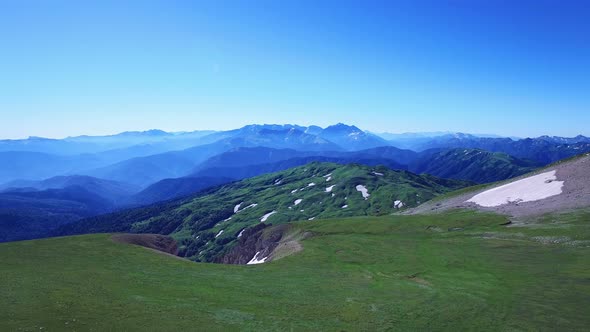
[0,0,590,138]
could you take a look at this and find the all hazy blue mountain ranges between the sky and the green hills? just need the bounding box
[0,123,590,240]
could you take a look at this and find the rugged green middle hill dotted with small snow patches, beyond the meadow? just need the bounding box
[56,163,469,261]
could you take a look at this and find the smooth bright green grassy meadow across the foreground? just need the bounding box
[0,212,590,330]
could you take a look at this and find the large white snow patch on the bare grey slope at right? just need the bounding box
[467,171,564,207]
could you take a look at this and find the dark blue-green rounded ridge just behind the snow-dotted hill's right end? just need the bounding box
[408,148,539,183]
